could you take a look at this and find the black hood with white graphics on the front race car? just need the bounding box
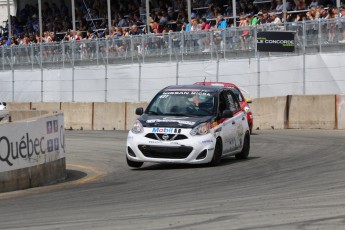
[138,114,213,128]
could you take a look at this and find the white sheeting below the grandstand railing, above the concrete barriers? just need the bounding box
[0,53,345,102]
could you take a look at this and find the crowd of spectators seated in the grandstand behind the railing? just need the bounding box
[0,0,345,46]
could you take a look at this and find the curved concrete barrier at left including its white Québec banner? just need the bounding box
[0,111,66,192]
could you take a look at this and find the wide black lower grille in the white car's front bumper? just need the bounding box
[138,145,193,159]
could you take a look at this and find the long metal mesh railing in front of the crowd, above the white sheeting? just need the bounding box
[0,18,345,70]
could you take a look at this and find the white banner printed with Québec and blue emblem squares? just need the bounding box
[0,113,65,172]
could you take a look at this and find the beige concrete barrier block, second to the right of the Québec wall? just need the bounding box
[93,102,126,130]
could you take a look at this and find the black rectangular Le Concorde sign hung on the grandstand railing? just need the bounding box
[257,31,295,52]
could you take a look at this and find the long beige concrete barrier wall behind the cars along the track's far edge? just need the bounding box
[6,95,345,130]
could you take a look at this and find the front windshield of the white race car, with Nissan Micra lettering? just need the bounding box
[146,89,215,116]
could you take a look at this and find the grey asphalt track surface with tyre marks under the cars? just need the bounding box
[0,130,345,230]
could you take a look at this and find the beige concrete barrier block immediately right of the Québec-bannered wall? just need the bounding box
[61,102,93,130]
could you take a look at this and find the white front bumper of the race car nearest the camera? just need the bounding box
[126,128,216,164]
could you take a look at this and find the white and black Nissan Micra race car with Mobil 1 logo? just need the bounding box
[126,85,250,168]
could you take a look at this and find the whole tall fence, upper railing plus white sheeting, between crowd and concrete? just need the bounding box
[0,19,345,102]
